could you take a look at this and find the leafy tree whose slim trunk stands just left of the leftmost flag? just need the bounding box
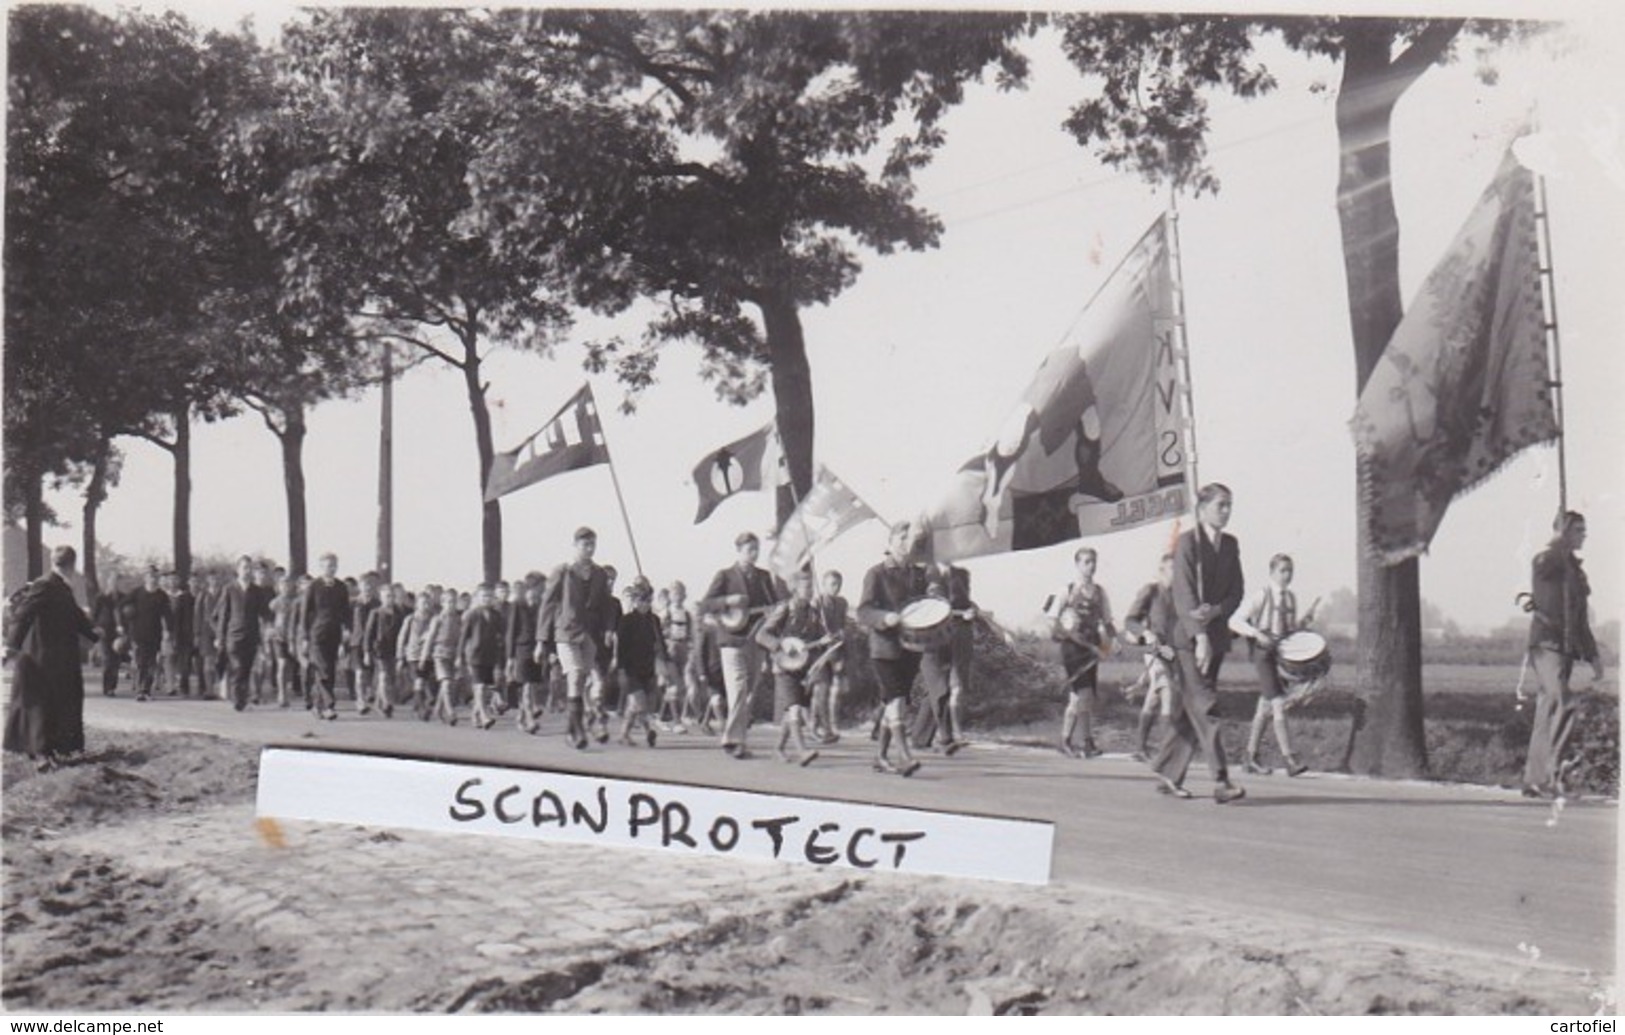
[263,10,650,580]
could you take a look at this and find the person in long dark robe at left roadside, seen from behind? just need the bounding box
[5,546,98,769]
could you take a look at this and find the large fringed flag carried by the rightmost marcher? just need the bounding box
[1350,154,1558,564]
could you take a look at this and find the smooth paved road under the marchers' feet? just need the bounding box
[73,695,1619,975]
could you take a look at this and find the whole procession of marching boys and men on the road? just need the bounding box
[82,484,1601,803]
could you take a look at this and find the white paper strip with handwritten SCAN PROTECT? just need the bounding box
[257,747,1055,884]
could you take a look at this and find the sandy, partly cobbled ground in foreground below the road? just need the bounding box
[0,733,1614,1014]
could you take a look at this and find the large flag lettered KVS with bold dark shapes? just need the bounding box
[926,218,1188,561]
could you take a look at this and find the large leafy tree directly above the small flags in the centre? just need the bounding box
[505,10,1034,518]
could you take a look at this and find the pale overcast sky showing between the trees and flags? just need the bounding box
[28,8,1625,629]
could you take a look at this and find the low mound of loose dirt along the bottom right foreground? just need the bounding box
[465,881,1588,1016]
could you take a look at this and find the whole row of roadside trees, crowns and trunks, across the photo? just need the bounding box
[5,5,1510,772]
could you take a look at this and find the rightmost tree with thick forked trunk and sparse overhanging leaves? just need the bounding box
[1060,15,1523,777]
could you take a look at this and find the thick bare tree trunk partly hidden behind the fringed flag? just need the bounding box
[1337,24,1427,777]
